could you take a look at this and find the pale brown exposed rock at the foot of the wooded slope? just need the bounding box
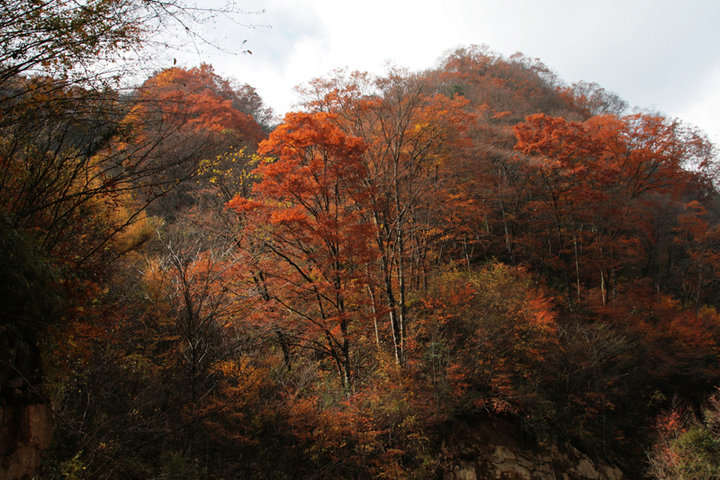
[443,420,626,480]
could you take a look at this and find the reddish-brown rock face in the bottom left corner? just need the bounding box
[0,398,55,480]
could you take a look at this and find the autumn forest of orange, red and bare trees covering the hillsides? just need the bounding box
[0,0,720,480]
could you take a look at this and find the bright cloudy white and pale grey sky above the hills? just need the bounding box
[167,0,720,146]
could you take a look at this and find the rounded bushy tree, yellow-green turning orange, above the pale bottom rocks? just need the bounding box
[421,264,557,423]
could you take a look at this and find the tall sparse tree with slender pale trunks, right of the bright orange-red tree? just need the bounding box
[304,71,469,364]
